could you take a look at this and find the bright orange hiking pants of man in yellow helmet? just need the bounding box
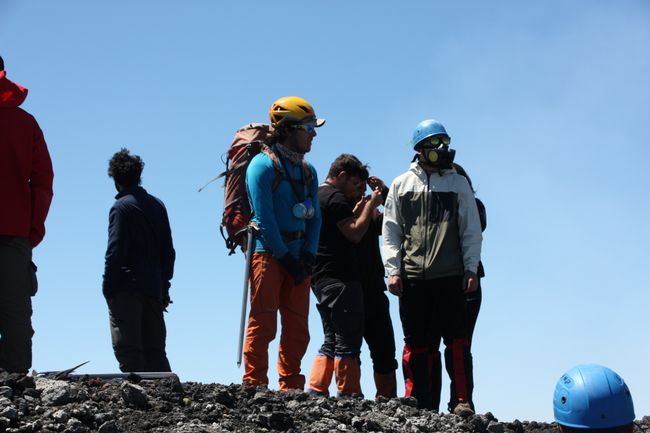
[243,253,310,391]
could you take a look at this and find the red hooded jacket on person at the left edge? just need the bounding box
[0,71,54,247]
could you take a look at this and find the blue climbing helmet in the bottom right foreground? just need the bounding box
[553,364,634,429]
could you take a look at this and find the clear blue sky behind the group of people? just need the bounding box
[0,0,650,421]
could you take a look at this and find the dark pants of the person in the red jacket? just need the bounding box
[0,236,36,373]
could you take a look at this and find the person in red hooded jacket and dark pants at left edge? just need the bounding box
[0,57,54,373]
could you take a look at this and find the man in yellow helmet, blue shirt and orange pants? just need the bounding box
[243,96,325,391]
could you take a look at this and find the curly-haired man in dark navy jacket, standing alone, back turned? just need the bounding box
[103,149,176,372]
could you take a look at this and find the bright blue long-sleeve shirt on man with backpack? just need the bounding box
[246,147,321,258]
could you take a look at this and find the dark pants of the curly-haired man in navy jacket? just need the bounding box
[107,291,171,372]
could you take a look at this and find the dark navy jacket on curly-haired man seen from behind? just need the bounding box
[103,186,176,299]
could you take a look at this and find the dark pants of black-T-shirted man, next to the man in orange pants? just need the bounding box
[312,279,364,358]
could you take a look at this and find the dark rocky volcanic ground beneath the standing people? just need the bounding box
[0,373,650,433]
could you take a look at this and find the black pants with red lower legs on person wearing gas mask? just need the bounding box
[400,276,474,410]
